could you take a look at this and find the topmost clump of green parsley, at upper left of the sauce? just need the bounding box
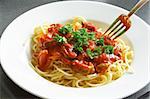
[59,24,73,34]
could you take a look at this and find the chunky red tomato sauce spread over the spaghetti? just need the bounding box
[38,23,122,74]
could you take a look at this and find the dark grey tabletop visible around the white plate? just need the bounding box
[0,0,150,99]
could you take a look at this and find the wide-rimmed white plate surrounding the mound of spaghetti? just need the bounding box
[0,1,150,99]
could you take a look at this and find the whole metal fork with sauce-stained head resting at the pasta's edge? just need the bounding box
[103,0,149,39]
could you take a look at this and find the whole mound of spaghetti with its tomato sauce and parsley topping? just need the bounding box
[31,17,133,88]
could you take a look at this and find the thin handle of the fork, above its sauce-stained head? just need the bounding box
[128,0,149,17]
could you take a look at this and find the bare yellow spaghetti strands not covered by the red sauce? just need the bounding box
[31,17,133,88]
